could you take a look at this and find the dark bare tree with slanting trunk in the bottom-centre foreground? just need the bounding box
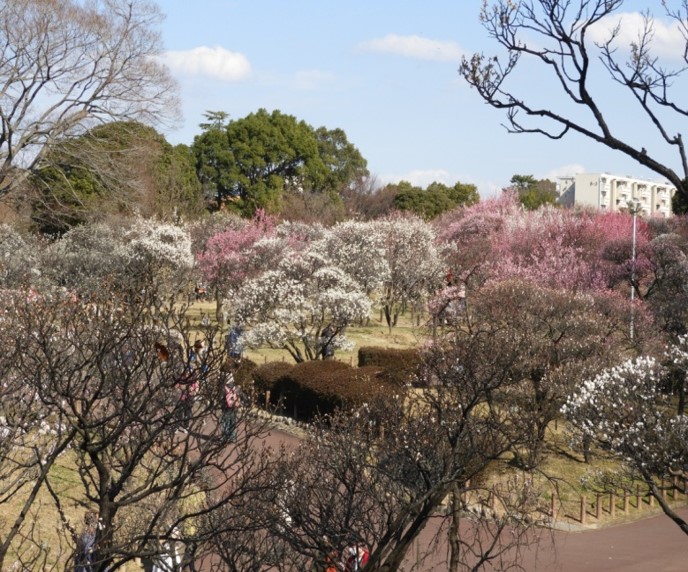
[239,332,552,571]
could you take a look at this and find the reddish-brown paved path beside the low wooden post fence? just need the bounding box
[254,429,688,572]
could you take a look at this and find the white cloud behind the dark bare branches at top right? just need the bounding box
[589,12,686,59]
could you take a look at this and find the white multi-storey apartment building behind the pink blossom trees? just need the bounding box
[558,173,676,217]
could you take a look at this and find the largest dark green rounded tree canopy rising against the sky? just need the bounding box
[193,109,368,216]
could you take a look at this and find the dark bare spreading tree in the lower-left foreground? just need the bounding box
[0,280,282,570]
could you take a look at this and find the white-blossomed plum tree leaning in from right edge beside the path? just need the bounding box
[562,357,688,534]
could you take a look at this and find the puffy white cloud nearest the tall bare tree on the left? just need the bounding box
[162,46,251,81]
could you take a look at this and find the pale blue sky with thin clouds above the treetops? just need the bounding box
[159,0,681,197]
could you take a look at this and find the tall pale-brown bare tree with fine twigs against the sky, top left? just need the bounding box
[0,0,178,196]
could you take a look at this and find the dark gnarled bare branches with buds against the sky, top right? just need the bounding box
[459,0,688,200]
